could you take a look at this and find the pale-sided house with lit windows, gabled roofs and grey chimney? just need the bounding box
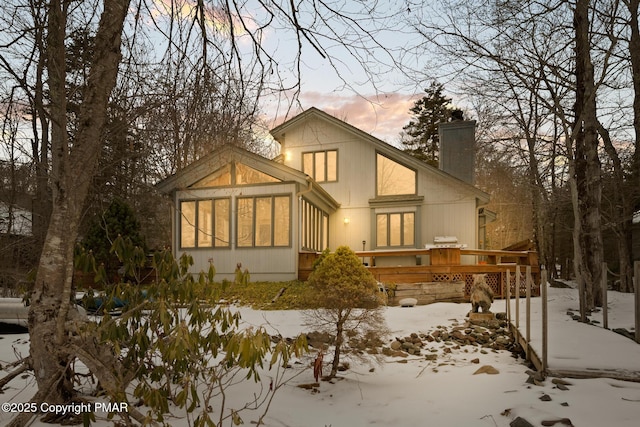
[158,108,489,280]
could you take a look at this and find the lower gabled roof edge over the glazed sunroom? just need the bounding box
[156,145,340,209]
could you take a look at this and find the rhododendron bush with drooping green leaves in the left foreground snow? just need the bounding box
[77,237,307,426]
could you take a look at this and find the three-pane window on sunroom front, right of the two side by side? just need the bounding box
[237,196,291,247]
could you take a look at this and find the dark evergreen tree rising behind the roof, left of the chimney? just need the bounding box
[401,81,459,167]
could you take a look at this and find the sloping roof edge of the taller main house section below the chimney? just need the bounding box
[271,107,489,204]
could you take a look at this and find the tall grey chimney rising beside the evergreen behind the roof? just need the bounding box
[438,117,476,185]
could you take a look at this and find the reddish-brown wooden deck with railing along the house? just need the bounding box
[298,248,540,300]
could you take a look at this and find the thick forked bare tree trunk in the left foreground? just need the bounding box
[29,0,130,410]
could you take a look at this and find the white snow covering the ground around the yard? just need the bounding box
[0,288,640,427]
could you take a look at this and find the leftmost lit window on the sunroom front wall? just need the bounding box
[180,199,229,248]
